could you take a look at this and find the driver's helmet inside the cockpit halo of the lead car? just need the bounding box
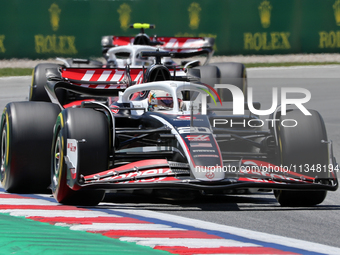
[148,90,182,111]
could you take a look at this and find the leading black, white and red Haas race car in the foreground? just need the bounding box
[0,51,338,206]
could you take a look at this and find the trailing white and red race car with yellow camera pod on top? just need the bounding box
[28,23,215,103]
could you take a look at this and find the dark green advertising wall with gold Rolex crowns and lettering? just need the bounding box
[0,0,340,59]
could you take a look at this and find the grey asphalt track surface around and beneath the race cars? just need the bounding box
[0,66,340,253]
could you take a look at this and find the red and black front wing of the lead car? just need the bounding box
[65,139,338,191]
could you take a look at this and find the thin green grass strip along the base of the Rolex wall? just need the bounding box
[0,62,340,77]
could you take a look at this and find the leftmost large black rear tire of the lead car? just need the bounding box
[0,102,60,193]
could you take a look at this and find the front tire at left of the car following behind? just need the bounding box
[28,63,66,103]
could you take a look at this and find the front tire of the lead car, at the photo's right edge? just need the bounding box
[274,110,329,206]
